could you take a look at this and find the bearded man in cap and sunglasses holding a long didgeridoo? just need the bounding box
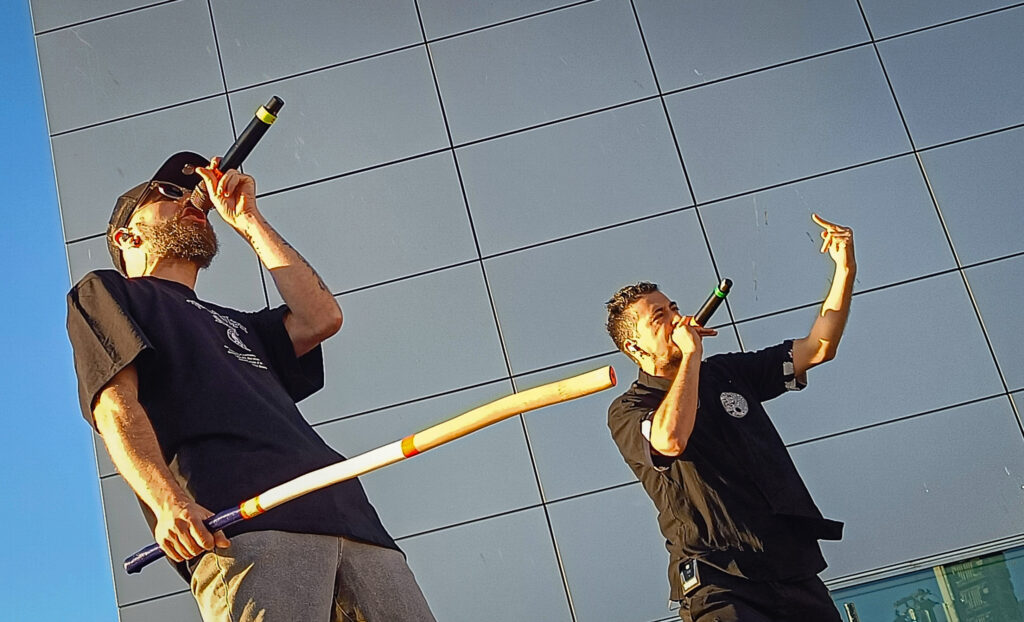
[68,152,433,622]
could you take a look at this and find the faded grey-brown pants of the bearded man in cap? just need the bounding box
[191,531,434,622]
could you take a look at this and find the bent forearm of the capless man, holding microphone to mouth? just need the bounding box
[650,355,700,456]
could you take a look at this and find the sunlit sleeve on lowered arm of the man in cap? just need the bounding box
[68,273,153,428]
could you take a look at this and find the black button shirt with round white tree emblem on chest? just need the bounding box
[608,341,843,600]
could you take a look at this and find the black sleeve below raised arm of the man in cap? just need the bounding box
[244,304,324,402]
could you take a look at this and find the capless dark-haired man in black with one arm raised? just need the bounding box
[607,214,856,622]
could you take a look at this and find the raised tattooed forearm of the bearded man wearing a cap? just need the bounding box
[239,214,342,355]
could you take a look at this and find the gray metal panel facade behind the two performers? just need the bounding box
[32,0,1024,622]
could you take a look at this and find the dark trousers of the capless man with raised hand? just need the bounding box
[679,564,842,622]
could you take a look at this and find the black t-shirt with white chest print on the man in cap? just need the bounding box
[68,271,398,577]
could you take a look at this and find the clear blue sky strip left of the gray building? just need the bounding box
[0,0,117,622]
